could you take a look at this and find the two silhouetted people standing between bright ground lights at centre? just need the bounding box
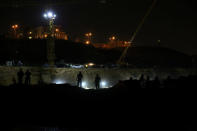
[77,72,101,89]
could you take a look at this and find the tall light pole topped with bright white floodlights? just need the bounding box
[44,11,56,67]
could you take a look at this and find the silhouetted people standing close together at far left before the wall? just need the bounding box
[13,69,31,85]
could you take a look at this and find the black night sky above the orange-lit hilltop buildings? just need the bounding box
[0,0,197,54]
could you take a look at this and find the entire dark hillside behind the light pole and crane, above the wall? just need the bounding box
[0,39,192,67]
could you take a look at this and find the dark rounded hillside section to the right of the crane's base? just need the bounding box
[126,47,192,67]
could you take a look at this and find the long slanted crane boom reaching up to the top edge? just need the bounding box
[117,0,157,65]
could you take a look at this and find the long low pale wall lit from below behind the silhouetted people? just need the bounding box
[0,67,194,88]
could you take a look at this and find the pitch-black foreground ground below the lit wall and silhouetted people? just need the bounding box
[0,76,197,131]
